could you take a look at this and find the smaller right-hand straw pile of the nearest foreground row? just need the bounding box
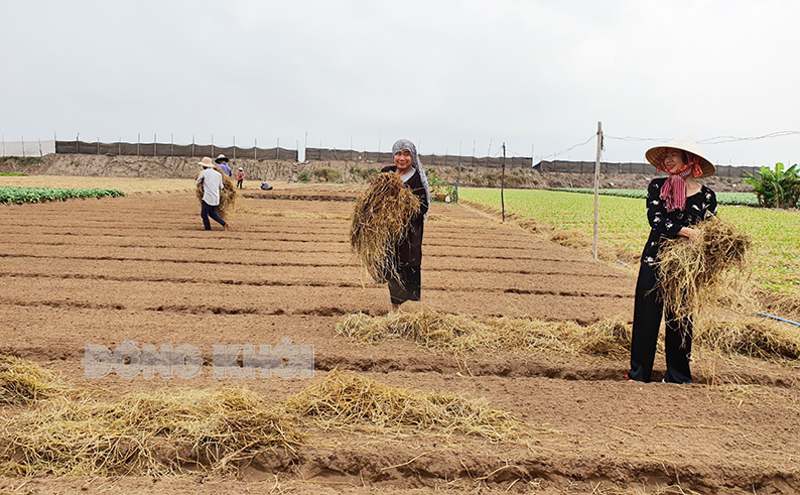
[286,370,524,440]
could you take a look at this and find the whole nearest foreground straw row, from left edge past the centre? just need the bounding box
[0,360,525,476]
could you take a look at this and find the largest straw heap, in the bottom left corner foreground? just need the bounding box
[0,388,300,476]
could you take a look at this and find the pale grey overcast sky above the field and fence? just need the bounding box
[0,0,800,165]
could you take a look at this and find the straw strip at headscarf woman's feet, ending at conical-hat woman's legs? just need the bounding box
[336,309,631,356]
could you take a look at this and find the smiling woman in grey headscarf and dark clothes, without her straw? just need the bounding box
[381,139,431,313]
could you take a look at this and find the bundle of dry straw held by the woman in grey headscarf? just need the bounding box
[350,172,419,283]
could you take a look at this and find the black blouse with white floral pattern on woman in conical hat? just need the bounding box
[642,177,717,266]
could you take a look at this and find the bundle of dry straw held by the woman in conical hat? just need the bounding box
[656,217,751,318]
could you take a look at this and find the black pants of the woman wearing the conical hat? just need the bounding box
[628,262,692,383]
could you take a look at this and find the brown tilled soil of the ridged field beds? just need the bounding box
[0,186,800,495]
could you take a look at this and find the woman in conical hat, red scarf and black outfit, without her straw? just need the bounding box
[625,136,717,383]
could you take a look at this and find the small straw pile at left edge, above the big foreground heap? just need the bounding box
[0,355,69,405]
